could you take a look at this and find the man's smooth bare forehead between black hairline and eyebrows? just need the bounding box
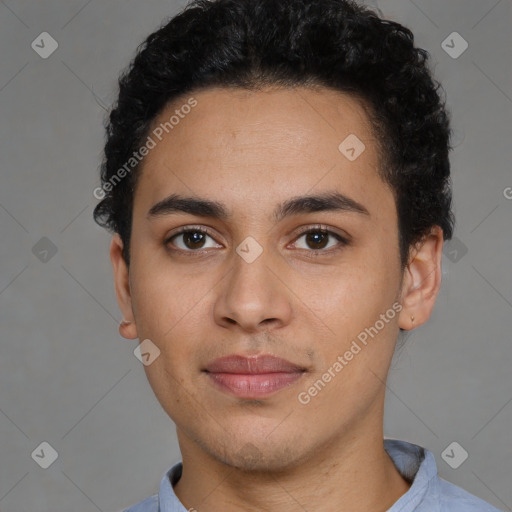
[135,88,389,219]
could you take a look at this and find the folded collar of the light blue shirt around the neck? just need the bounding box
[158,439,439,512]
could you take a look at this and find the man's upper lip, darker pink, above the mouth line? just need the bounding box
[206,354,305,374]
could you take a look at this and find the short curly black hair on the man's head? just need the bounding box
[94,0,454,269]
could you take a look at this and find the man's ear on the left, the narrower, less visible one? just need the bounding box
[110,233,137,340]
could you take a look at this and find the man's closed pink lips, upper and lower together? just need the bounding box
[204,354,306,398]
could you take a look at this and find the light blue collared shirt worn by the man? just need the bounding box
[124,439,502,512]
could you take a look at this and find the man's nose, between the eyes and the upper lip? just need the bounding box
[214,244,292,333]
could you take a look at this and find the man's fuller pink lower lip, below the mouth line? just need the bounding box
[206,372,304,398]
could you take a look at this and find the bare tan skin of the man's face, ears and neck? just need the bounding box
[110,88,443,512]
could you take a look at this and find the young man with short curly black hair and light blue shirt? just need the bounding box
[95,0,497,512]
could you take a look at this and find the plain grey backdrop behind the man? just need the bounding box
[0,0,512,512]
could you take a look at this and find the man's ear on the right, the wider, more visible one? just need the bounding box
[398,226,443,330]
